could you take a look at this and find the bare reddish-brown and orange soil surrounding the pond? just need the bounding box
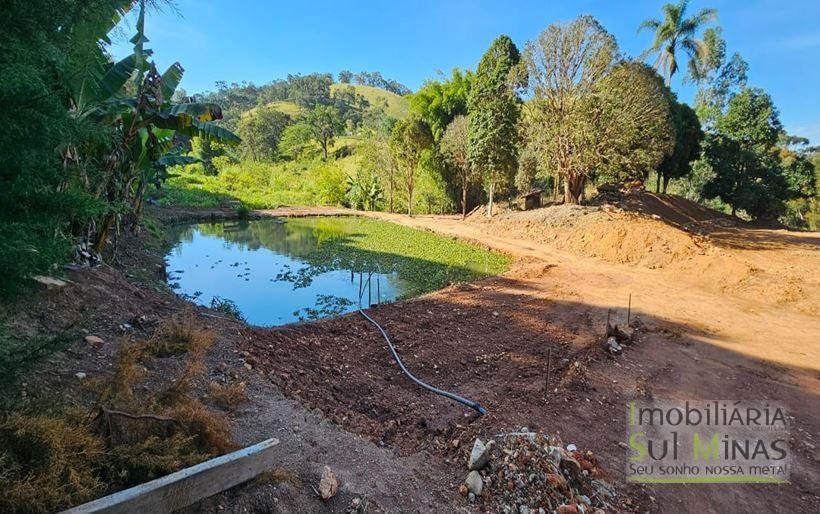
[8,194,820,512]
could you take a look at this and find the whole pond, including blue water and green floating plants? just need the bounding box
[166,217,509,326]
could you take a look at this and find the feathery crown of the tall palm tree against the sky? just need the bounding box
[638,0,717,86]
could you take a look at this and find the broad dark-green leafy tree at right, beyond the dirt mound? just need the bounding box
[703,88,792,219]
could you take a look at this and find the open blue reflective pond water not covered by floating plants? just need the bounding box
[166,218,412,326]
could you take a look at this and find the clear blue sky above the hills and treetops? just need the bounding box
[113,0,820,144]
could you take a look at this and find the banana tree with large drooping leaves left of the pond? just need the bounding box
[87,0,240,252]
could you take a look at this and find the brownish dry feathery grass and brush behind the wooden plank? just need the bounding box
[0,318,234,512]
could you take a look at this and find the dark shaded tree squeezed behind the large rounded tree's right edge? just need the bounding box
[655,98,704,193]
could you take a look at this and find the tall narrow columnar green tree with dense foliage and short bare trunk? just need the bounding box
[467,35,526,217]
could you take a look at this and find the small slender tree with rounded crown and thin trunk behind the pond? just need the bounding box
[389,116,433,215]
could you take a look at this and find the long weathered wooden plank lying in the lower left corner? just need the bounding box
[63,438,279,514]
